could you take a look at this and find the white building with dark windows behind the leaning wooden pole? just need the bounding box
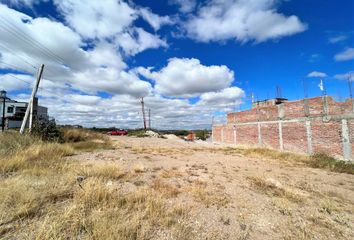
[0,91,48,128]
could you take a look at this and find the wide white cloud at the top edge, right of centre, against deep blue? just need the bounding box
[184,0,307,42]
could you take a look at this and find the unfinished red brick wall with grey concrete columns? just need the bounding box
[213,97,354,160]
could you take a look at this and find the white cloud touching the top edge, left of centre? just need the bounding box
[54,0,138,39]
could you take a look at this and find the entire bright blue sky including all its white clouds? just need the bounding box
[0,0,354,128]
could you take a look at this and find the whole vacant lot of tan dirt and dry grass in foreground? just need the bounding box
[0,134,354,239]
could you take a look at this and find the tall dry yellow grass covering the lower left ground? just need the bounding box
[0,129,193,239]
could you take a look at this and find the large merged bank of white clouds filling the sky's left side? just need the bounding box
[0,0,246,129]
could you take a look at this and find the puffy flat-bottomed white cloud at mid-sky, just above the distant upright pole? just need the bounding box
[138,58,234,97]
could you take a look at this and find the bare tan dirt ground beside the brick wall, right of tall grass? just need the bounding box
[74,137,354,239]
